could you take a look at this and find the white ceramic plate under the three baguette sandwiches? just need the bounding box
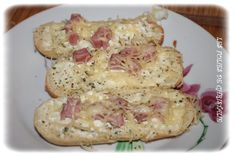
[5,6,227,151]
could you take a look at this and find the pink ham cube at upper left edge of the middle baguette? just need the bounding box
[73,48,92,64]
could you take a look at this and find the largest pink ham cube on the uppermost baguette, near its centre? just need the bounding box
[91,27,112,49]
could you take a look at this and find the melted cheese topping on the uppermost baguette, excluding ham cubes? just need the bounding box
[40,14,163,55]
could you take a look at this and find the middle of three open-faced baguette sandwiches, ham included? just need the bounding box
[46,45,183,97]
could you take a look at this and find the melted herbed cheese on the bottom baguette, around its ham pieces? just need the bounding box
[34,88,197,139]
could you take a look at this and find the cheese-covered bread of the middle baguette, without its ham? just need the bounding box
[46,45,183,97]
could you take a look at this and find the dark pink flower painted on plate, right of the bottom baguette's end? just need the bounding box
[199,89,226,122]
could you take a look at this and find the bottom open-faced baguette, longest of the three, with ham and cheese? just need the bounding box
[34,88,200,145]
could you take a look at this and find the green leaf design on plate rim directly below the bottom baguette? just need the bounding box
[116,141,144,152]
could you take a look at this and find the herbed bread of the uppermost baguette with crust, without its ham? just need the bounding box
[34,13,164,58]
